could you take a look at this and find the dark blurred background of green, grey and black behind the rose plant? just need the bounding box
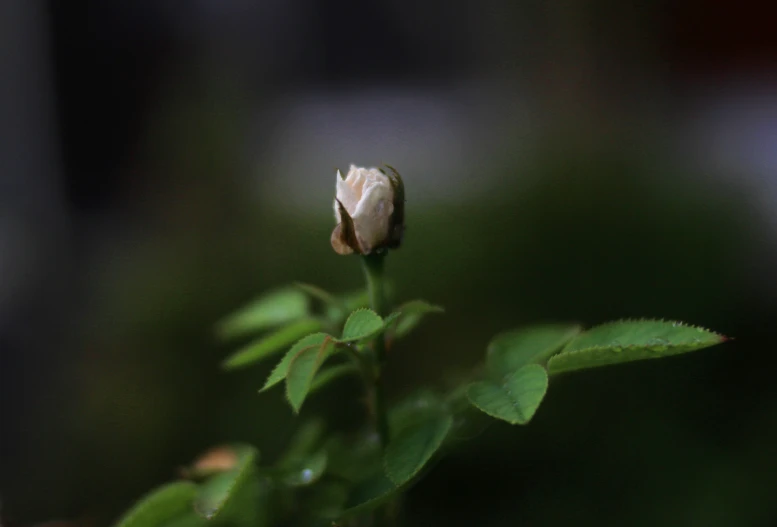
[0,0,777,527]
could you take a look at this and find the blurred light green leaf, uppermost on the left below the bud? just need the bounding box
[216,287,308,339]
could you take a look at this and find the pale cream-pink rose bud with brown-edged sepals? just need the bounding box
[331,165,405,255]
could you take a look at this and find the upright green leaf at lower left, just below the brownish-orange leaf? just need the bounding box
[194,445,259,520]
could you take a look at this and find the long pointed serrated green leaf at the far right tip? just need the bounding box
[548,320,726,373]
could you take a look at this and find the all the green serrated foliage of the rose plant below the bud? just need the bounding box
[118,266,725,527]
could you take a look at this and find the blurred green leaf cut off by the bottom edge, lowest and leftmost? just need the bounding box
[114,481,197,527]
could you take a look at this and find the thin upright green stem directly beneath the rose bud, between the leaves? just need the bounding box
[362,254,389,448]
